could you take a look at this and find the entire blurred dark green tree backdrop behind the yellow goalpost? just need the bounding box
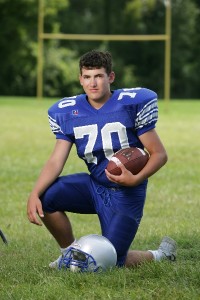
[0,0,200,99]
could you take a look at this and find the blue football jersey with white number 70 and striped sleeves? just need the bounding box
[48,88,158,186]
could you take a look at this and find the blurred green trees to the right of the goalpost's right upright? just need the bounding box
[171,0,200,98]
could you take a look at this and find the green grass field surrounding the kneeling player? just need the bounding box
[0,97,200,300]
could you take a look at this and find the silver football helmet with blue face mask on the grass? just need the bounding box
[59,234,117,272]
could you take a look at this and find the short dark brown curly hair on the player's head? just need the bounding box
[79,50,112,75]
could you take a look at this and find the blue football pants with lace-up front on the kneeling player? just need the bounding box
[41,173,147,266]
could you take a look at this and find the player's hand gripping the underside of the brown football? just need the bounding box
[105,163,141,186]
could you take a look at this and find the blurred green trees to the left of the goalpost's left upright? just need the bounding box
[0,0,37,95]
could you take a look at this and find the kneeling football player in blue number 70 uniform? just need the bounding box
[27,50,176,267]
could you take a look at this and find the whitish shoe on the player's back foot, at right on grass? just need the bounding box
[158,236,177,261]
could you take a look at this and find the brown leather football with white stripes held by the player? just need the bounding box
[106,147,149,175]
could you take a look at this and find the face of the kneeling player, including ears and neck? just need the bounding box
[79,68,115,108]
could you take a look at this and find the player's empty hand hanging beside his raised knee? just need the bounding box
[27,196,44,226]
